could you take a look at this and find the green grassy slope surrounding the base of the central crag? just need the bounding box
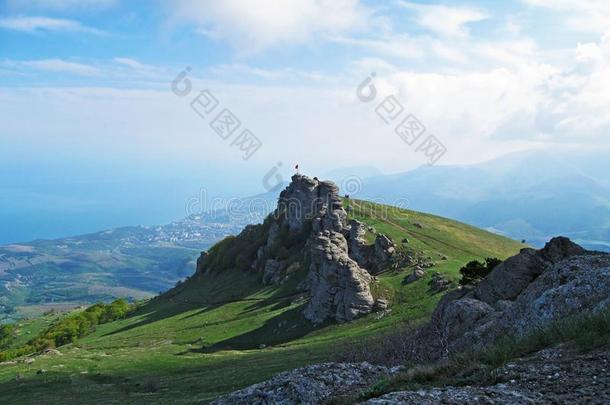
[0,201,522,404]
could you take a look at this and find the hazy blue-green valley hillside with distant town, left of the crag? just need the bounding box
[0,211,252,321]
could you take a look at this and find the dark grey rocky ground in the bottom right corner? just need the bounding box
[366,347,610,405]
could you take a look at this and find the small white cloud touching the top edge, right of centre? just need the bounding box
[398,1,489,37]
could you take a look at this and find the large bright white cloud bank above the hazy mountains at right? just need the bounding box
[342,31,610,150]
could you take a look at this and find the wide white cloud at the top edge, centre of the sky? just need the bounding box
[171,0,369,53]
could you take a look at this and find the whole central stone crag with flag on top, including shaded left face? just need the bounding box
[198,175,394,324]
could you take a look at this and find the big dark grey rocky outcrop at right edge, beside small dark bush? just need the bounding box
[413,238,610,360]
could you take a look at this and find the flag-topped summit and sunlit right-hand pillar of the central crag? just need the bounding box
[272,175,400,324]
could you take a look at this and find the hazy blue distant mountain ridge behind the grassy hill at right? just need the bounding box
[346,151,610,251]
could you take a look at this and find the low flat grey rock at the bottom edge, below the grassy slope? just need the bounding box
[213,363,392,405]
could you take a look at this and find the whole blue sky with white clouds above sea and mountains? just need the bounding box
[0,0,610,243]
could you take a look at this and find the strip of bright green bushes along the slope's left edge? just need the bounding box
[0,299,135,362]
